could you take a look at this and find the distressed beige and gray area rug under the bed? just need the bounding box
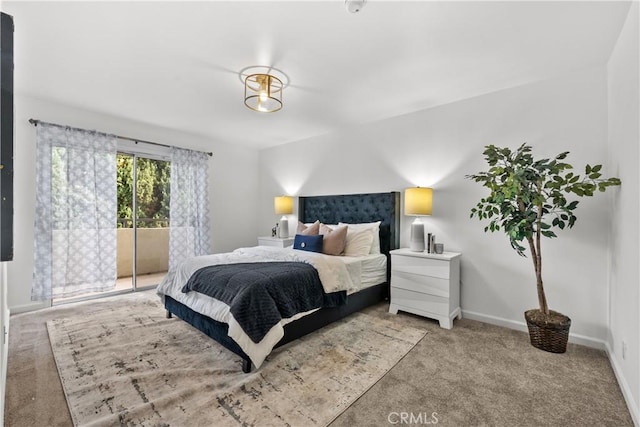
[47,299,426,426]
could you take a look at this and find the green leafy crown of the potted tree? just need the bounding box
[465,143,620,262]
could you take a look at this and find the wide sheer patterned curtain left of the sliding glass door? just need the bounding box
[31,123,117,301]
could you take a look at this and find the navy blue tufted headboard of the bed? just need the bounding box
[298,191,400,256]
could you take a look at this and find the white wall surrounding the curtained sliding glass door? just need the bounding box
[7,95,258,313]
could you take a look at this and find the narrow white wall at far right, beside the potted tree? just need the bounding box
[607,2,640,424]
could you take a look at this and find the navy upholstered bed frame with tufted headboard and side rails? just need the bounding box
[165,191,400,373]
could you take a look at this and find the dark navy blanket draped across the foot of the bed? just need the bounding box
[182,262,347,343]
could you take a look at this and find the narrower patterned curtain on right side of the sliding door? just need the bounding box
[169,148,211,269]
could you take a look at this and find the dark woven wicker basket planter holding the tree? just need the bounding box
[524,309,571,353]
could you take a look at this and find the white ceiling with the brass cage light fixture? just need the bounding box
[2,0,629,148]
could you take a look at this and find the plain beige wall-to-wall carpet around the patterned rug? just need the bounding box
[4,294,633,427]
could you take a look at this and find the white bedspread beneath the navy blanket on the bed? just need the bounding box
[157,246,360,368]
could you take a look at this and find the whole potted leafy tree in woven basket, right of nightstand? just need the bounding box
[466,144,620,353]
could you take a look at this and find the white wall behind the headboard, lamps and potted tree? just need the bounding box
[260,67,610,347]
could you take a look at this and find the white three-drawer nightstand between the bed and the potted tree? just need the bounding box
[389,249,462,329]
